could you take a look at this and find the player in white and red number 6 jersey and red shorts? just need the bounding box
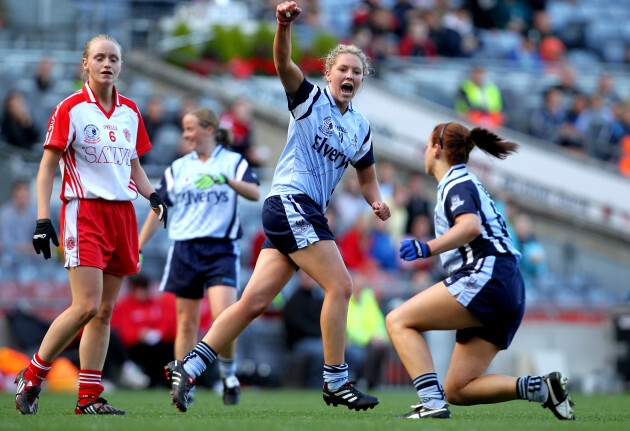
[15,35,167,415]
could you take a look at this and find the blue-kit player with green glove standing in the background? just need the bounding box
[139,108,260,404]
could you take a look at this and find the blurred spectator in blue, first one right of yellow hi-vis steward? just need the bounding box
[529,87,566,145]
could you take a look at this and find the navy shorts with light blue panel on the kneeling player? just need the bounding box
[444,256,525,349]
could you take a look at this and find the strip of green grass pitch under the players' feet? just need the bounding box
[0,388,630,431]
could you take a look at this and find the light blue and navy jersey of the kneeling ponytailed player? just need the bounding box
[435,164,521,274]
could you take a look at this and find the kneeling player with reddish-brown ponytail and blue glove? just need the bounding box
[386,123,574,419]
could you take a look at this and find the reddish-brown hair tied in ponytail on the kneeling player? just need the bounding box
[431,123,518,166]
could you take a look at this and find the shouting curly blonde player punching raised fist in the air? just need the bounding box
[167,2,390,410]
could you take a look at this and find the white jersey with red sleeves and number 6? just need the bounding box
[44,83,151,202]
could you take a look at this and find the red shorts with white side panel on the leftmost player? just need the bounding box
[61,199,139,275]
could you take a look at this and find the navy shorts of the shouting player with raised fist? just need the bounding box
[262,194,335,255]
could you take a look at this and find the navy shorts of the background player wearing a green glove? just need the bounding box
[160,238,240,299]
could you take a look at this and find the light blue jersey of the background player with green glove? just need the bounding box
[155,145,259,241]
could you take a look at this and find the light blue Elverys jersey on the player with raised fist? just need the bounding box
[268,79,374,213]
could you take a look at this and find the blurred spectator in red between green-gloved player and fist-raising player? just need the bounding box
[219,98,266,167]
